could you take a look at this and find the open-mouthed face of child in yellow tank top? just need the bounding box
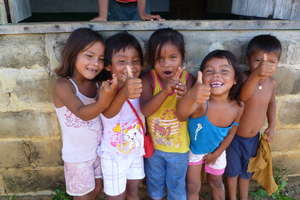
[154,43,182,80]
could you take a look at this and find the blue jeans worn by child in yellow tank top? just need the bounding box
[145,150,189,200]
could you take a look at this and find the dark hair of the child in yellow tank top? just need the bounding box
[147,28,185,67]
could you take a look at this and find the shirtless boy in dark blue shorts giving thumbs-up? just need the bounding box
[225,35,281,200]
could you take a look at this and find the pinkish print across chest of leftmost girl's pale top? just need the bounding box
[64,109,101,133]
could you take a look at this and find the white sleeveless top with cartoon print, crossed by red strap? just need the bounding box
[98,98,144,158]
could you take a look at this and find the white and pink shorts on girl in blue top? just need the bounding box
[189,151,226,175]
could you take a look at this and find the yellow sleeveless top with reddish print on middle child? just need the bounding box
[147,70,189,153]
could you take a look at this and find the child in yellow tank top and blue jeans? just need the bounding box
[141,28,192,200]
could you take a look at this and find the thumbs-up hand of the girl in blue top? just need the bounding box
[192,71,210,104]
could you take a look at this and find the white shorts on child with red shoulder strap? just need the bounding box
[101,155,145,196]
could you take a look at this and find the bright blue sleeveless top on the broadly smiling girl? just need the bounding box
[188,103,239,154]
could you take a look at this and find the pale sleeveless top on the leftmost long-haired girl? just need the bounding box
[55,79,102,162]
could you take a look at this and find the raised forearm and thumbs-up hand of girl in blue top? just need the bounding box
[176,71,210,121]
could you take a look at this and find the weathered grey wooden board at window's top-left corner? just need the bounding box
[8,0,31,23]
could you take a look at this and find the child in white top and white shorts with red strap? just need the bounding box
[98,32,145,200]
